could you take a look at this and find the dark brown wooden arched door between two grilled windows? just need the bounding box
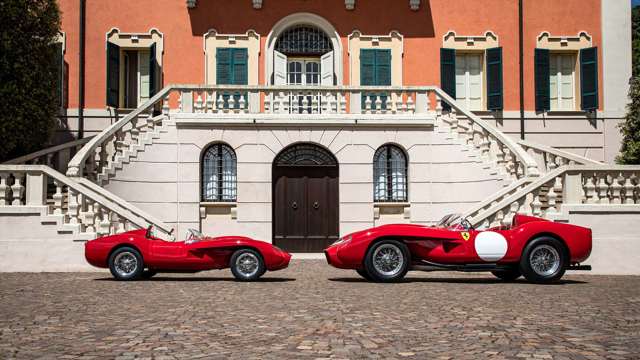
[272,143,339,252]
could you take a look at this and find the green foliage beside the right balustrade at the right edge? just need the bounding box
[617,76,640,165]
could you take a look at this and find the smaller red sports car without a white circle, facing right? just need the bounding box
[84,227,291,281]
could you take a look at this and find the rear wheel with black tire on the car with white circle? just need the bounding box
[519,236,569,284]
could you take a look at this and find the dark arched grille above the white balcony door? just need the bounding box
[275,25,333,56]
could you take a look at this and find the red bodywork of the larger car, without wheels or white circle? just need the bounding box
[325,215,591,269]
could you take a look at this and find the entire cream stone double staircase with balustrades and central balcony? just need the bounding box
[0,85,640,270]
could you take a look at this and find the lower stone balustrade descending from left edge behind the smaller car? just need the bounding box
[0,165,172,238]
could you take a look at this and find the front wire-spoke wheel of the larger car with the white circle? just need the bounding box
[364,240,411,282]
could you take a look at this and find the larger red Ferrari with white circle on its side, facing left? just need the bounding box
[325,214,591,283]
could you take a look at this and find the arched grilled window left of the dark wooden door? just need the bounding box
[201,144,237,201]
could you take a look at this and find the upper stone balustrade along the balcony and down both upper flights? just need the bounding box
[67,85,539,180]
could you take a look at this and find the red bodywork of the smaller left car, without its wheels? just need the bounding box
[85,229,291,271]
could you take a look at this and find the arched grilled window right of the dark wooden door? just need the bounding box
[373,145,407,202]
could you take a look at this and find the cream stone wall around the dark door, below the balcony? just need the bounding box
[106,121,503,241]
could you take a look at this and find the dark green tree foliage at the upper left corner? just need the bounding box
[0,0,60,162]
